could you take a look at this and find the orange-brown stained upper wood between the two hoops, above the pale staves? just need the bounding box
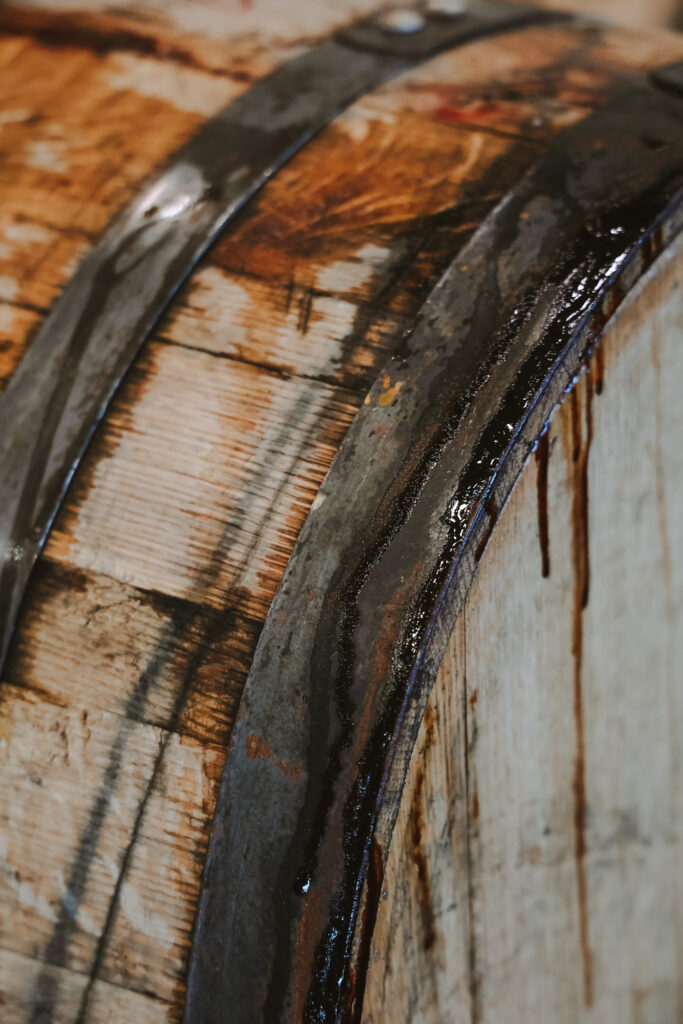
[209,23,683,285]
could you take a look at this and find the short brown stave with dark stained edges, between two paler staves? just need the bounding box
[5,560,260,748]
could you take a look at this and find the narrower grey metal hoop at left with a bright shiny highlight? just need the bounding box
[0,3,557,670]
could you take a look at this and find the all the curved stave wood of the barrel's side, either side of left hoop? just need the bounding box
[0,3,683,1024]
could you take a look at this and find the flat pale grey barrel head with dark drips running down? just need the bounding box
[364,230,683,1024]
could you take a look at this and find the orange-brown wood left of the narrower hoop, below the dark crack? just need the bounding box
[0,33,236,382]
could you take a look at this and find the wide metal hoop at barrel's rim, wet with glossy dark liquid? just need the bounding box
[185,68,683,1024]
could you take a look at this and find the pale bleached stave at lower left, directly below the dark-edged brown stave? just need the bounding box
[0,684,225,1001]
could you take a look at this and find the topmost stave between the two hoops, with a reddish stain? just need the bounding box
[329,22,683,144]
